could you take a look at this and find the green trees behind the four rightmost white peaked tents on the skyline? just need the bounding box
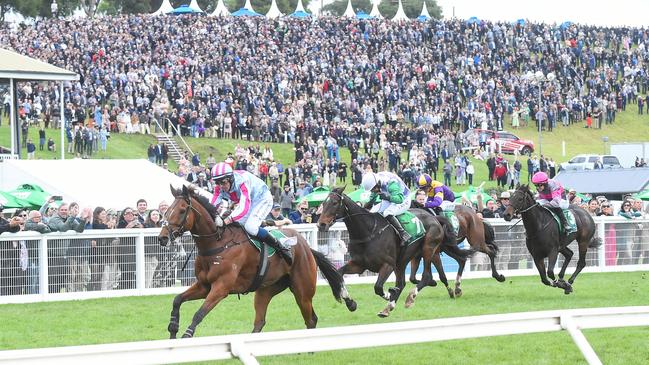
[322,0,442,19]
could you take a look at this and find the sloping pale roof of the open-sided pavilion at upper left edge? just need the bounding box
[0,48,79,81]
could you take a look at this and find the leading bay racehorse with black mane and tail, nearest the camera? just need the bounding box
[158,186,356,338]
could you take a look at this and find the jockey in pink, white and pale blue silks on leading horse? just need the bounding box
[211,162,293,265]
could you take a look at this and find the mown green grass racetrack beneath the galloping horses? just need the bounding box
[0,272,649,365]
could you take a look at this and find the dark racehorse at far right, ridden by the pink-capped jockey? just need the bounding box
[504,185,599,294]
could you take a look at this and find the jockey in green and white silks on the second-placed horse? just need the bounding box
[361,171,411,246]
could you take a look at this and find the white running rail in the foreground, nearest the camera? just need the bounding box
[0,306,649,365]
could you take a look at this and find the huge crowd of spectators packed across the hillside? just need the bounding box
[0,15,649,291]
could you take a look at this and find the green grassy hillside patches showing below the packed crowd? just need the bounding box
[0,104,649,191]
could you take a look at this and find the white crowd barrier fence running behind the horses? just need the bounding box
[0,217,649,304]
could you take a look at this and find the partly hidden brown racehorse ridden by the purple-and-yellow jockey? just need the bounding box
[410,203,505,298]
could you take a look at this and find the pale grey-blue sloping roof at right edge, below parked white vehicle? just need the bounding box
[555,168,649,194]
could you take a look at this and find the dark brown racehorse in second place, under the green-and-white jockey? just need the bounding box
[318,188,472,317]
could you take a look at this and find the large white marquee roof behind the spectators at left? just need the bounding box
[0,159,187,210]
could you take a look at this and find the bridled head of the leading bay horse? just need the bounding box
[158,185,197,246]
